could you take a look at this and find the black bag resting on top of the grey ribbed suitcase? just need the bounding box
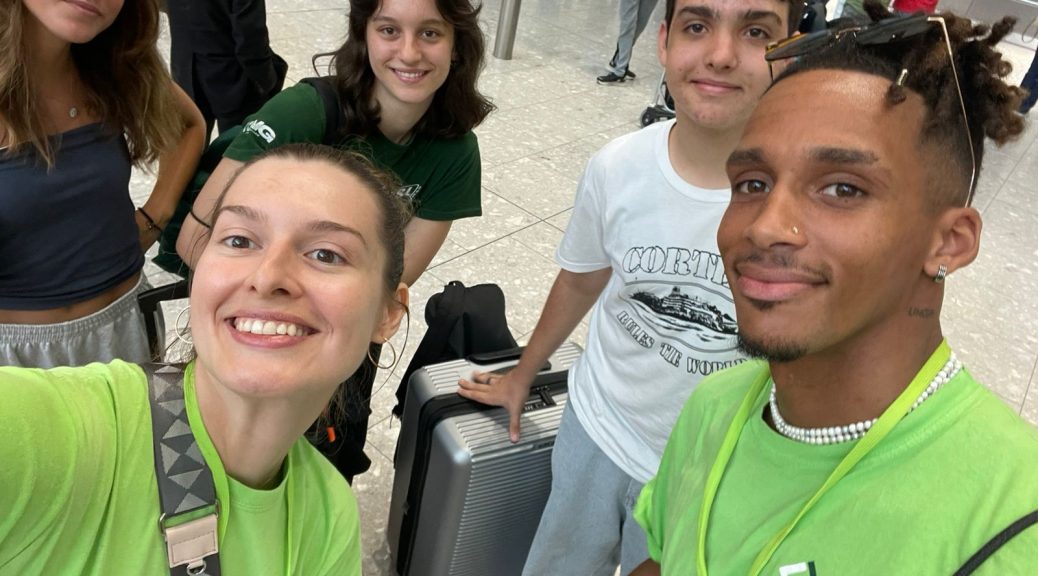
[392,280,519,416]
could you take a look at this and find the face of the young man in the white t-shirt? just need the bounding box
[657,0,789,131]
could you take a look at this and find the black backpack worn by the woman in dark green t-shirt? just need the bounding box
[152,76,346,278]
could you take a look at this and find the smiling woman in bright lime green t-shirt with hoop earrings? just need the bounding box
[0,144,408,576]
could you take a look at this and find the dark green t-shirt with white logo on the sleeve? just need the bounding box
[223,83,483,220]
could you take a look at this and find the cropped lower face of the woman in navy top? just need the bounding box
[21,0,122,44]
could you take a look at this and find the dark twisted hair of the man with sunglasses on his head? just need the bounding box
[772,0,1025,210]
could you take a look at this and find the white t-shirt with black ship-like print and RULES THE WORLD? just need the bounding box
[555,121,743,483]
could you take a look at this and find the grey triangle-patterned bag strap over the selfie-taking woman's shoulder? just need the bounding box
[141,364,220,576]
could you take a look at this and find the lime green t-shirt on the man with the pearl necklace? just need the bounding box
[635,361,1038,576]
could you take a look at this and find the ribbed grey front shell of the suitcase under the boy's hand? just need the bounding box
[449,397,565,576]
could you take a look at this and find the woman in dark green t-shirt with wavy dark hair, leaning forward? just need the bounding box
[176,0,493,481]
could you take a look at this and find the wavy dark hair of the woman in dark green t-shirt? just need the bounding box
[315,0,495,138]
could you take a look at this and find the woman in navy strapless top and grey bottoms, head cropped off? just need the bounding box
[0,0,204,367]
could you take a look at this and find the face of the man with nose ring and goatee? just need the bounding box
[717,70,939,359]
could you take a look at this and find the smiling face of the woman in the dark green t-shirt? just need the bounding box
[365,0,454,112]
